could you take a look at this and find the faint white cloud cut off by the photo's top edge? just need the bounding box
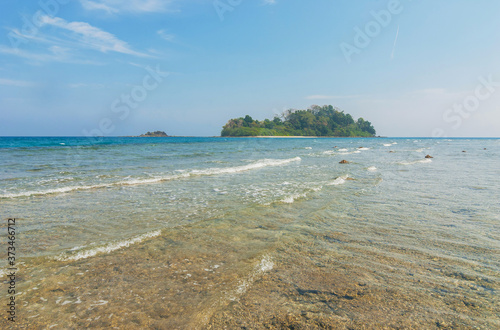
[80,0,173,14]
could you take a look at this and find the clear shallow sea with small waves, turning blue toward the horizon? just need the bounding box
[0,137,500,329]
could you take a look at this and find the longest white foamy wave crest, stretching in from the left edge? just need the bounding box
[0,157,302,198]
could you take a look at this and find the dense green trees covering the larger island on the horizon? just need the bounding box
[221,105,375,137]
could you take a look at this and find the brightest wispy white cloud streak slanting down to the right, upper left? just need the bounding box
[41,16,149,57]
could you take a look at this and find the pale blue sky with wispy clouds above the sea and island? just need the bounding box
[0,0,500,137]
